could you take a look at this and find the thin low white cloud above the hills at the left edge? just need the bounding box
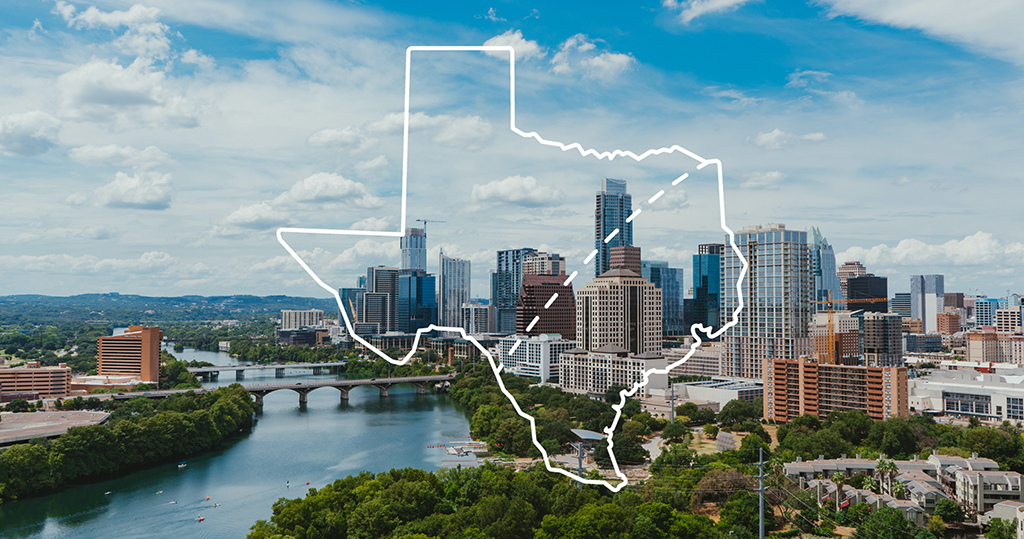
[0,251,178,274]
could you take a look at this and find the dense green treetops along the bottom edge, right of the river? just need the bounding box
[248,464,757,539]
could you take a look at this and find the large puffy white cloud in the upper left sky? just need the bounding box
[57,58,199,128]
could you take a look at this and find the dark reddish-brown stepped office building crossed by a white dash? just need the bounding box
[515,275,575,340]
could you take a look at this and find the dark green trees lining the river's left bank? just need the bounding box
[0,384,255,501]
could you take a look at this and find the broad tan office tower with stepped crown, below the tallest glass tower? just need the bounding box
[577,270,662,354]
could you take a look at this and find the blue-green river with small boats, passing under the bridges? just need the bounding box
[0,349,474,539]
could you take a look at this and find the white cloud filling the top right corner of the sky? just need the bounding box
[817,0,1024,65]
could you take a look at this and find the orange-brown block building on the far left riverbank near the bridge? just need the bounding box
[96,326,164,382]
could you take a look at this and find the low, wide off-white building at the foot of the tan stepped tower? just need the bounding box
[558,344,669,399]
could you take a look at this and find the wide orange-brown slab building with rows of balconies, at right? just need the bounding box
[764,356,908,422]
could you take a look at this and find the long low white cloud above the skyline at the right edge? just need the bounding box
[836,231,1024,266]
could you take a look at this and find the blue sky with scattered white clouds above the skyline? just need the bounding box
[0,0,1024,298]
